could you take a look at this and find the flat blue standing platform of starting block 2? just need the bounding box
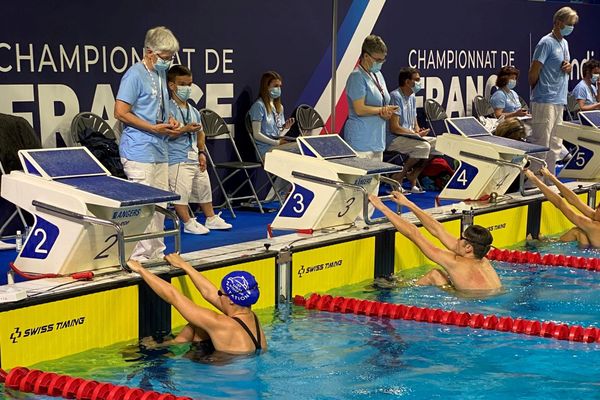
[54,176,179,207]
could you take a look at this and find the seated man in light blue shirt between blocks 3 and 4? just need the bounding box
[386,68,435,193]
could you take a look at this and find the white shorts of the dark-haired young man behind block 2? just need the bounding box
[169,163,212,205]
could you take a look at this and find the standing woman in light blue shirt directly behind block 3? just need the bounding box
[344,35,398,160]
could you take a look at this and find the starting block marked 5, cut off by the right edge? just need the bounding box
[556,111,600,180]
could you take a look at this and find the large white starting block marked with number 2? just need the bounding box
[1,147,180,275]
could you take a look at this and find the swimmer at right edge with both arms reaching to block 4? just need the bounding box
[525,168,600,248]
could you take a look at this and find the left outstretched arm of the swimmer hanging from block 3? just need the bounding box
[369,195,456,273]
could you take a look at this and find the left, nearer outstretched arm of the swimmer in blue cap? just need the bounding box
[127,260,221,334]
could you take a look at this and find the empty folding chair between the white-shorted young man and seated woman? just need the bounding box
[200,108,264,218]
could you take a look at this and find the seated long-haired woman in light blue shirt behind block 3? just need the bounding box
[249,71,296,161]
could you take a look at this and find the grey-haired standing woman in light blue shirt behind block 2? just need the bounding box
[115,26,181,261]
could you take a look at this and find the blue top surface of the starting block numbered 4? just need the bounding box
[446,117,550,154]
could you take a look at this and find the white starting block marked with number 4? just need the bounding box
[435,117,549,200]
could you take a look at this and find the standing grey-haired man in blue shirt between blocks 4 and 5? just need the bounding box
[529,7,579,179]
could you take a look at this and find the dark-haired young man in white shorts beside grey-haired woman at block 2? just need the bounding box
[167,65,231,235]
